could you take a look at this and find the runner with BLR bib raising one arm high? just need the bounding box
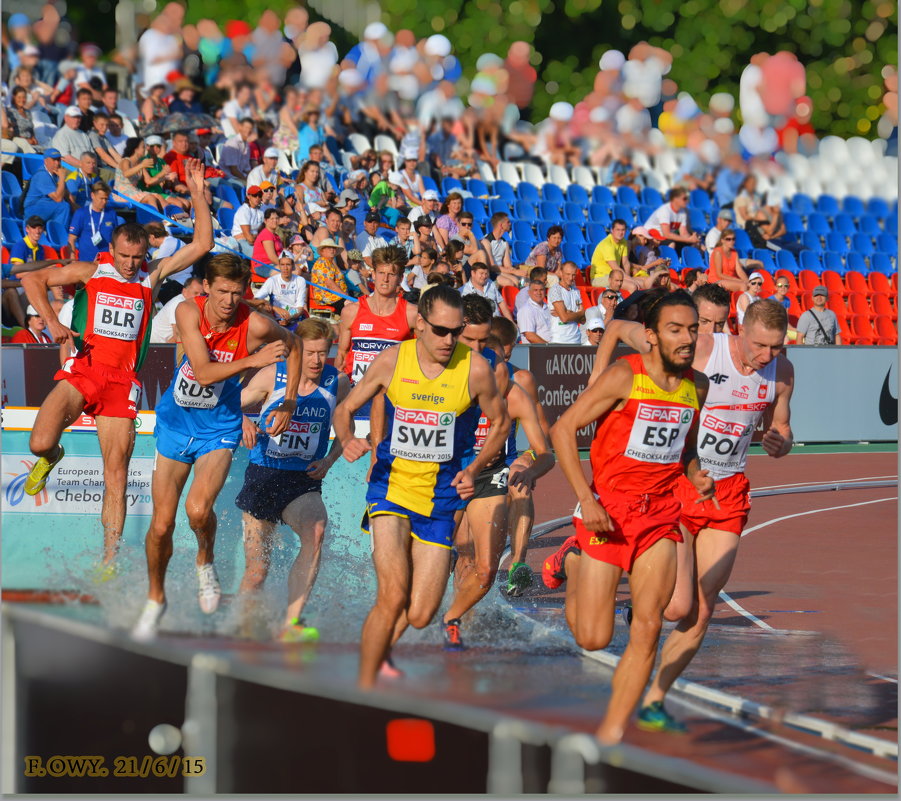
[22,160,213,568]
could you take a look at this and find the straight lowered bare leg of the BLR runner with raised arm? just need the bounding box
[95,417,135,564]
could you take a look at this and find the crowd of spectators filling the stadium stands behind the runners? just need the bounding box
[0,2,897,343]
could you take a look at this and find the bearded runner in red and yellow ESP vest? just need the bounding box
[543,291,714,744]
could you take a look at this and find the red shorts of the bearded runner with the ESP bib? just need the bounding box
[573,484,682,572]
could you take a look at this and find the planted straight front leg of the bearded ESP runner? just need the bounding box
[596,539,676,744]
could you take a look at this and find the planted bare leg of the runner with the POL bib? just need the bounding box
[633,528,739,705]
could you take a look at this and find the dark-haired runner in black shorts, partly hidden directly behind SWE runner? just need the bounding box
[444,295,554,650]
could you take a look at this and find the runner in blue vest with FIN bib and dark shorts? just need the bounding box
[235,317,350,642]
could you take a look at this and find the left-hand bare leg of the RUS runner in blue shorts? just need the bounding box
[144,453,191,603]
